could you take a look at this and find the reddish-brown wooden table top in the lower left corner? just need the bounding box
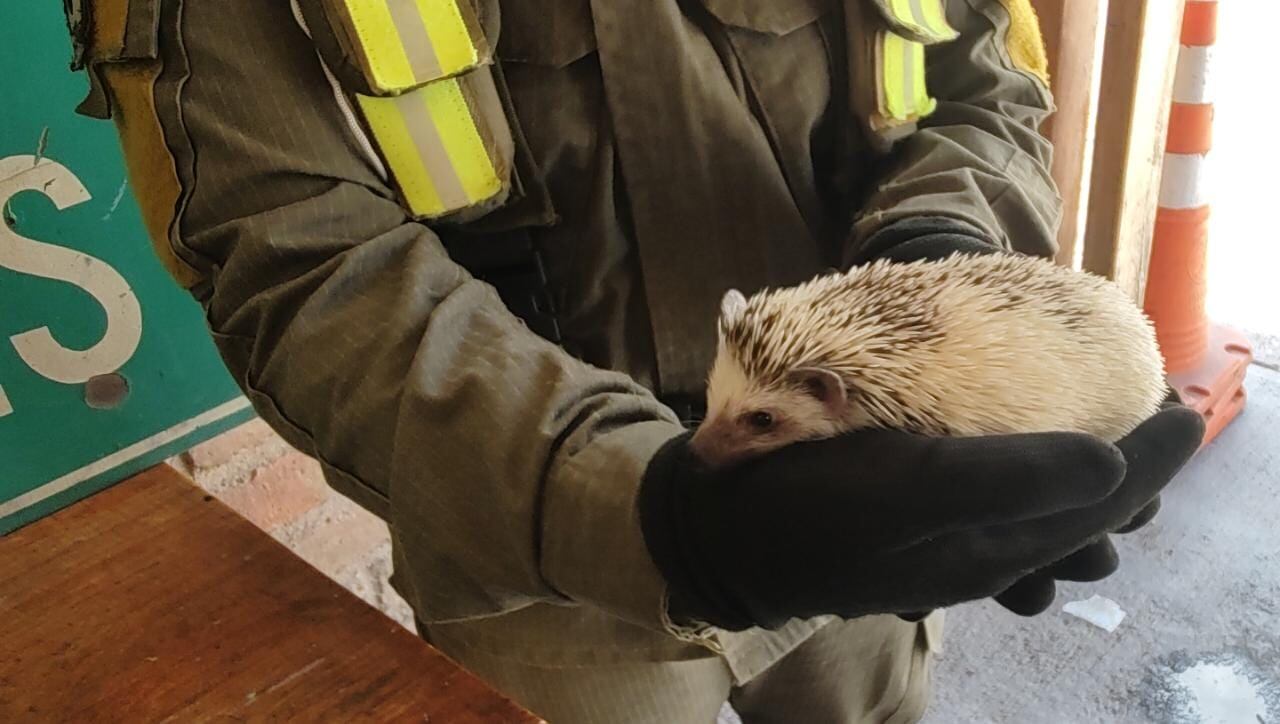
[0,466,539,724]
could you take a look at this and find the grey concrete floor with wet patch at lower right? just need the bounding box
[925,361,1280,724]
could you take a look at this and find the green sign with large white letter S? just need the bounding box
[0,1,252,535]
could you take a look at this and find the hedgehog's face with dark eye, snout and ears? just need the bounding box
[690,354,845,469]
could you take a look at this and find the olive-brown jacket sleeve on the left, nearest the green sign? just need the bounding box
[83,0,682,628]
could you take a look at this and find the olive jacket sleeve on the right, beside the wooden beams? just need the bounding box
[849,0,1061,256]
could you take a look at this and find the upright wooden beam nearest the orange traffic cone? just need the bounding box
[1083,0,1185,303]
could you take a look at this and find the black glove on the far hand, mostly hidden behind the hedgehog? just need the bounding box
[852,216,1180,620]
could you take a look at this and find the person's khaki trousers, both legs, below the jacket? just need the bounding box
[417,617,934,724]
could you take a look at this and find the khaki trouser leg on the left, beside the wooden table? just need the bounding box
[419,624,732,724]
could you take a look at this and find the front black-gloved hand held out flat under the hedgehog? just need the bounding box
[639,407,1203,631]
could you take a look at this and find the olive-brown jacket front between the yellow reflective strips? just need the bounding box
[442,0,872,397]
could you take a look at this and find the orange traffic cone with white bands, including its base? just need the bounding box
[1143,0,1253,444]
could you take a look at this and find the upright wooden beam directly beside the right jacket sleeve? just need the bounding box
[1032,0,1111,269]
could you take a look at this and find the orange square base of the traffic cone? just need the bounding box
[1169,325,1253,448]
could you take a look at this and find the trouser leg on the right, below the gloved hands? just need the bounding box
[730,617,940,724]
